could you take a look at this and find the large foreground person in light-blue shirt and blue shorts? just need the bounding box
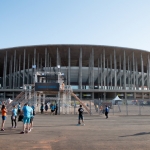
[20,103,33,134]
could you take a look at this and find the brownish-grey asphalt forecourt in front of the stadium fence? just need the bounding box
[0,114,150,150]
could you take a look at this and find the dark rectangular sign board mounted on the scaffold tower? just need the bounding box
[35,83,59,91]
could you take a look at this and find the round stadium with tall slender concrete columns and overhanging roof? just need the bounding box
[0,45,150,100]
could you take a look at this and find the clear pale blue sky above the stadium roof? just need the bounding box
[0,0,150,51]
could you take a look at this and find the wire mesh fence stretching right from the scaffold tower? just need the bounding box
[70,100,150,116]
